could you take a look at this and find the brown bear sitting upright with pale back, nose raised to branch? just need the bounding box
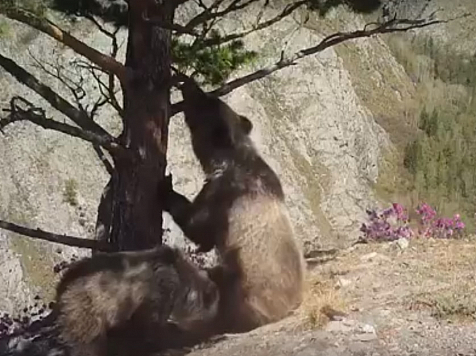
[161,81,304,332]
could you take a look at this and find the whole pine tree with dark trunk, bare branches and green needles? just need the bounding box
[0,0,444,250]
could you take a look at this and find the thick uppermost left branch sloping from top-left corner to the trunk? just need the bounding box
[0,6,126,83]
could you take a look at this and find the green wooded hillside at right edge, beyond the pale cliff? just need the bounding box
[389,35,476,229]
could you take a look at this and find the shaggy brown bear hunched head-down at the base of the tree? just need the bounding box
[56,245,219,356]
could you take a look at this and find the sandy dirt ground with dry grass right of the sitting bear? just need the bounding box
[178,239,476,356]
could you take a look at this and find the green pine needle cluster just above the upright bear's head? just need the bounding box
[172,31,257,85]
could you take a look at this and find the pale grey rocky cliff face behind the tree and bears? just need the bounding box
[0,2,472,312]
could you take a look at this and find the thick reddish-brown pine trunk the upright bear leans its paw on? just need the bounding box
[106,0,175,250]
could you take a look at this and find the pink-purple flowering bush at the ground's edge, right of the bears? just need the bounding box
[360,203,465,241]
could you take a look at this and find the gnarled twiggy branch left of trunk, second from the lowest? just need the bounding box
[0,96,126,155]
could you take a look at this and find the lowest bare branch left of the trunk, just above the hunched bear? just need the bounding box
[0,220,113,252]
